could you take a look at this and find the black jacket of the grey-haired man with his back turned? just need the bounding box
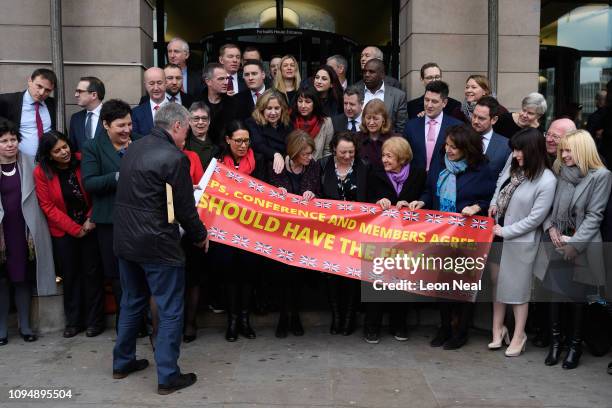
[113,127,206,266]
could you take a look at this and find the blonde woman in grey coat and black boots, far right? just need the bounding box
[536,130,612,369]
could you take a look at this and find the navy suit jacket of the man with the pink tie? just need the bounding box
[404,114,463,169]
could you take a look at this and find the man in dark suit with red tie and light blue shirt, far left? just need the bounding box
[0,68,57,156]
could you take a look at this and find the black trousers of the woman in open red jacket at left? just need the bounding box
[53,230,104,328]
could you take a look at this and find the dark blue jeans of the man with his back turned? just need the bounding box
[113,258,185,384]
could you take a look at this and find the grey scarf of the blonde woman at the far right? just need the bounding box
[551,164,584,235]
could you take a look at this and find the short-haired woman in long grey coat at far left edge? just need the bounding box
[0,118,56,346]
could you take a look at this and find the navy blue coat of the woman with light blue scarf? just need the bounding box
[421,155,497,215]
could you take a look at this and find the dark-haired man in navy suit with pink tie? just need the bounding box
[404,81,462,170]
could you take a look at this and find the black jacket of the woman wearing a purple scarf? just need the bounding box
[368,167,427,205]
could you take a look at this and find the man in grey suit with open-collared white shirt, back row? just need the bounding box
[363,59,408,133]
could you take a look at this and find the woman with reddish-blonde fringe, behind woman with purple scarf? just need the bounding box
[358,99,401,167]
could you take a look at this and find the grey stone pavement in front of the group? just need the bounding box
[0,316,612,408]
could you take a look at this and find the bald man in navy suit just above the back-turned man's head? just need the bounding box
[132,67,168,135]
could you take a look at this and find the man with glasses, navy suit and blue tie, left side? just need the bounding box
[68,77,105,152]
